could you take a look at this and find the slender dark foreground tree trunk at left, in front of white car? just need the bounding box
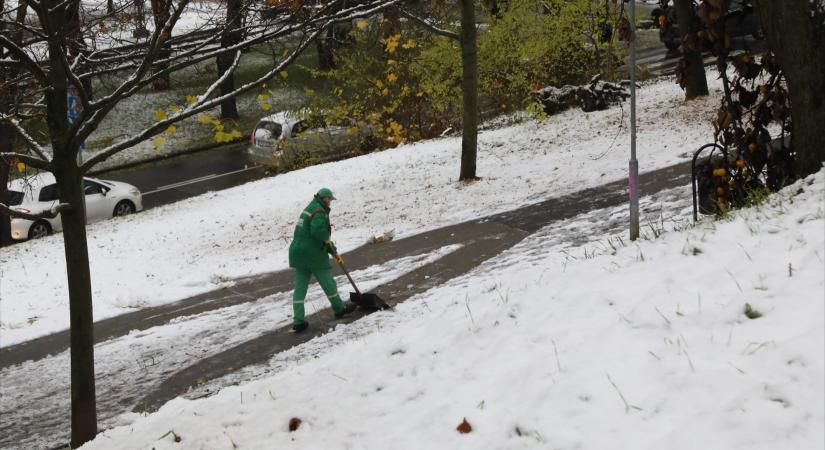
[44,0,97,442]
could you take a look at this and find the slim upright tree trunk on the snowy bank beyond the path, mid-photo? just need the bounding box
[459,0,478,181]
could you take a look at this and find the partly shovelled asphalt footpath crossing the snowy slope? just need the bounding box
[0,158,689,448]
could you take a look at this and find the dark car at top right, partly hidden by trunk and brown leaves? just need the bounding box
[650,0,762,51]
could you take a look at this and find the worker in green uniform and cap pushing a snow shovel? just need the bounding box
[289,188,357,332]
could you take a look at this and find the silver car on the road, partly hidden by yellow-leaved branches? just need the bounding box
[248,111,372,168]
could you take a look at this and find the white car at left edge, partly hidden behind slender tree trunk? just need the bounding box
[8,173,143,240]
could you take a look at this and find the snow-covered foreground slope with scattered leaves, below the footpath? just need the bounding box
[82,170,825,450]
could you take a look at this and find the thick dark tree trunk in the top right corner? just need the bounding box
[754,0,825,176]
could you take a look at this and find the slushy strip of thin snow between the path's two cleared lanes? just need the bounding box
[0,245,461,450]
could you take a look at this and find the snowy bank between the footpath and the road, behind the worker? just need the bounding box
[0,75,719,346]
